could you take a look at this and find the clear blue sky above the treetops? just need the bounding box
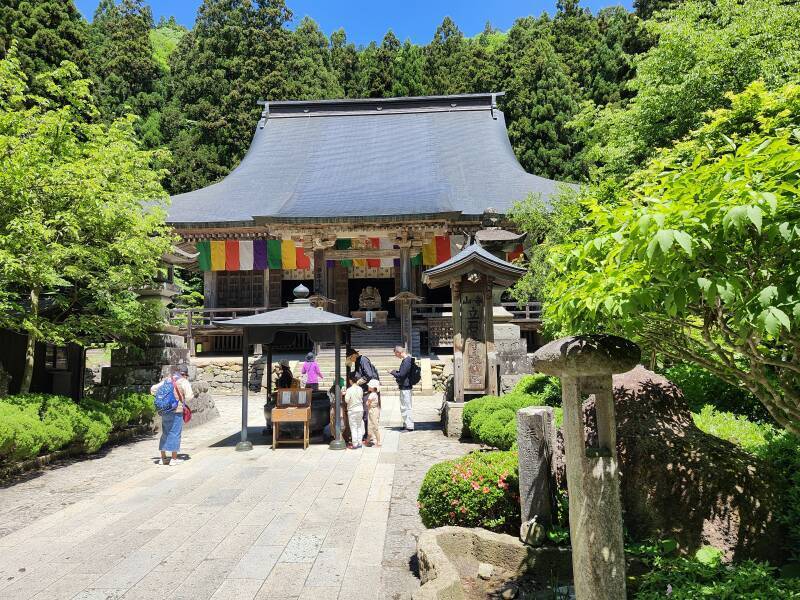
[75,0,632,44]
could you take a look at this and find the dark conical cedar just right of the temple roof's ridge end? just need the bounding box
[504,39,583,180]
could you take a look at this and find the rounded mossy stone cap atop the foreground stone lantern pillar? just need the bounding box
[533,335,642,377]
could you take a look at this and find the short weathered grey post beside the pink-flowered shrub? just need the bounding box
[517,406,556,527]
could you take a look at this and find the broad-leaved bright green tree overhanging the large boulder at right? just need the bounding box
[546,82,800,434]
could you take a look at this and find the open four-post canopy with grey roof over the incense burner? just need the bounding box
[217,285,364,450]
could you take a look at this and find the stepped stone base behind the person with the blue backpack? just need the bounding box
[95,333,219,427]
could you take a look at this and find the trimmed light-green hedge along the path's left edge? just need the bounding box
[0,394,155,462]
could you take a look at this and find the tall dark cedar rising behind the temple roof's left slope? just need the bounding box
[168,0,300,192]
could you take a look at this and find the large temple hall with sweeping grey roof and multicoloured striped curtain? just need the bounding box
[167,93,561,352]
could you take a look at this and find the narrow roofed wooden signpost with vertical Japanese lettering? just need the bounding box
[422,244,525,402]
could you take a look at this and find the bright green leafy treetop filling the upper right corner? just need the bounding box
[590,0,800,176]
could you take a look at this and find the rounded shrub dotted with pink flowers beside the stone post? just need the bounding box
[417,452,520,534]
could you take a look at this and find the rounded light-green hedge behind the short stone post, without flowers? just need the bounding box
[463,374,563,450]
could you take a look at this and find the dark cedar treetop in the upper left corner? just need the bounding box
[0,0,89,94]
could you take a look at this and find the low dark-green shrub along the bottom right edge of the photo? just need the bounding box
[633,557,800,600]
